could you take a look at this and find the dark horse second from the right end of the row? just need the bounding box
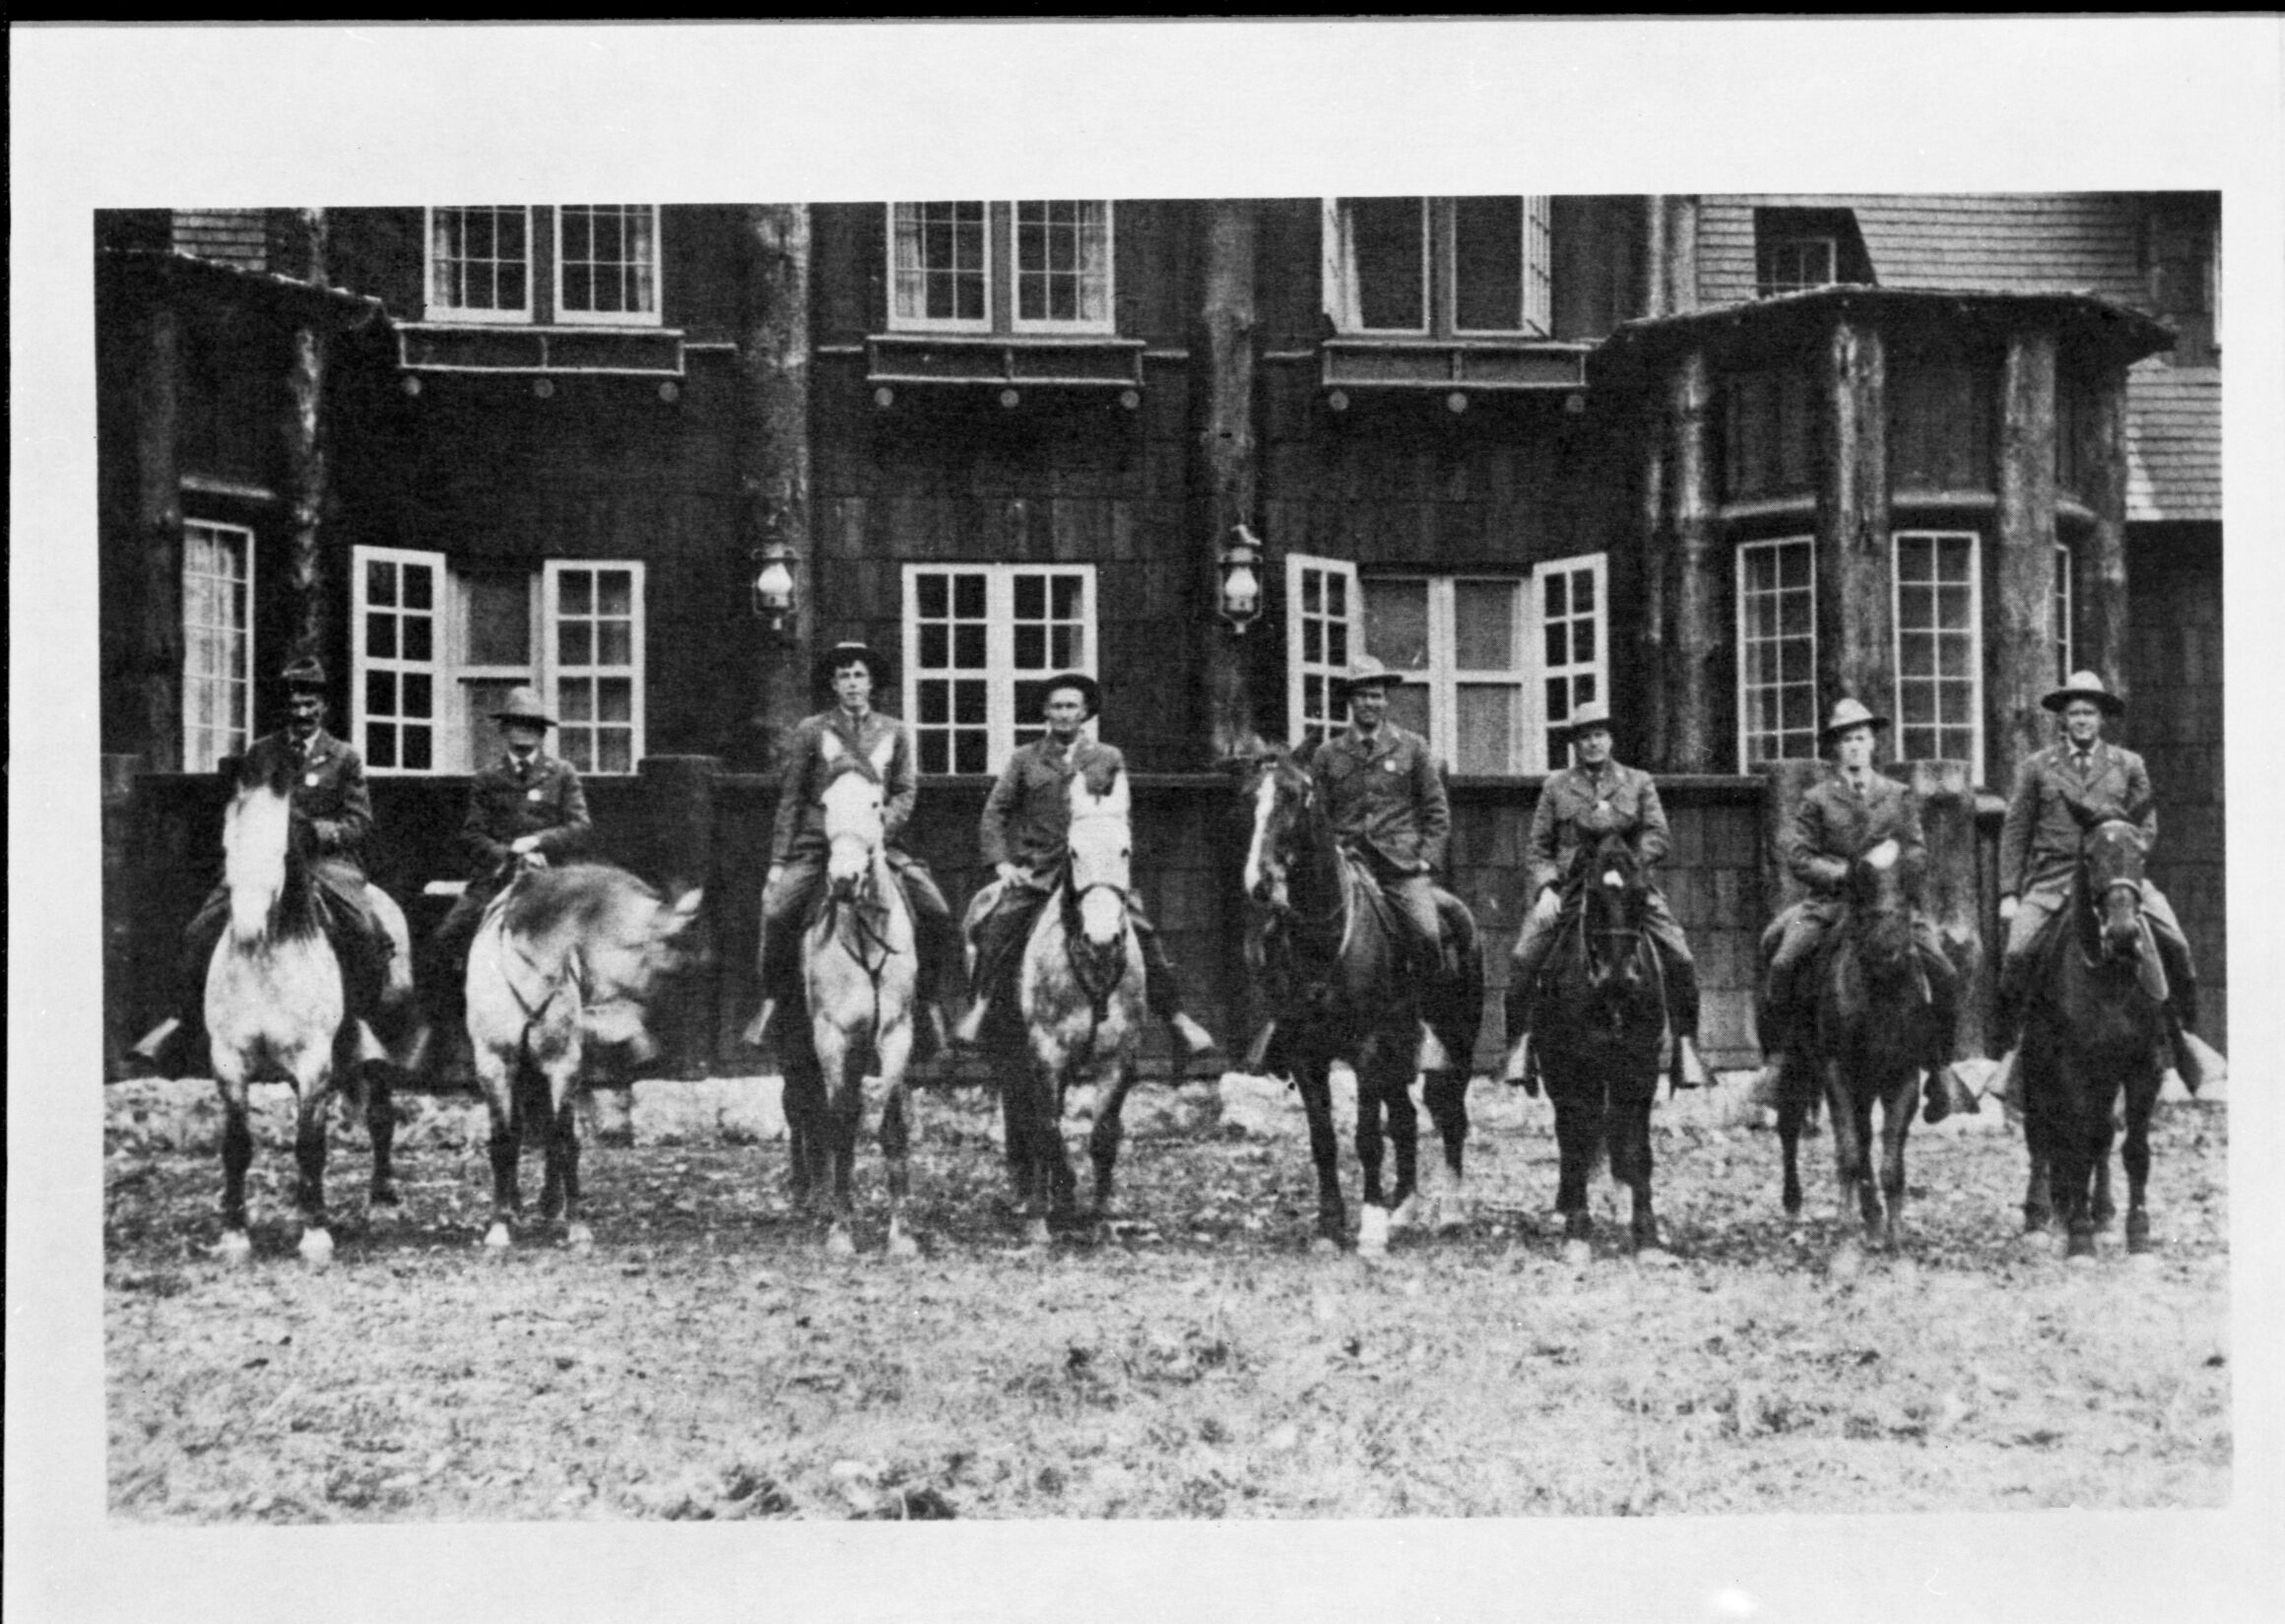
[1778,840,1937,1247]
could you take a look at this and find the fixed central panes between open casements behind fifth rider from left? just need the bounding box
[1362,575,1537,774]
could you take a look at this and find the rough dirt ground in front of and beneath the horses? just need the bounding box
[102,1092,2230,1524]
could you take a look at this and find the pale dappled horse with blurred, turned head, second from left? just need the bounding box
[466,864,704,1247]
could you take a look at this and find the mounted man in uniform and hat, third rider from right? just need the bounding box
[1506,703,1707,1087]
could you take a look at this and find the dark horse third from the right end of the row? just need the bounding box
[1508,834,1665,1252]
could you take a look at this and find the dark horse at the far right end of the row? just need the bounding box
[2022,820,2166,1257]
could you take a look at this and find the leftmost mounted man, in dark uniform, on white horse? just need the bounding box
[121,656,427,1075]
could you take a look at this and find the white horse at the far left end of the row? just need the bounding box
[206,751,398,1267]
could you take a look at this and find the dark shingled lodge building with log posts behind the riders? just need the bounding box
[96,194,2228,1069]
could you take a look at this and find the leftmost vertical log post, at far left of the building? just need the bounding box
[126,298,183,772]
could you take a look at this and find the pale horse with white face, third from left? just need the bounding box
[786,733,921,1259]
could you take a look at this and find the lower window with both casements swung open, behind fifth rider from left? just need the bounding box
[1286,552,1611,777]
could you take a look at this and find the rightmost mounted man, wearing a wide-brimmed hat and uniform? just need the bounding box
[1991,672,2223,1103]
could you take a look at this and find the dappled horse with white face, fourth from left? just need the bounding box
[1003,772,1144,1240]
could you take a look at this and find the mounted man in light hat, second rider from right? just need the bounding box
[1752,699,1977,1122]
